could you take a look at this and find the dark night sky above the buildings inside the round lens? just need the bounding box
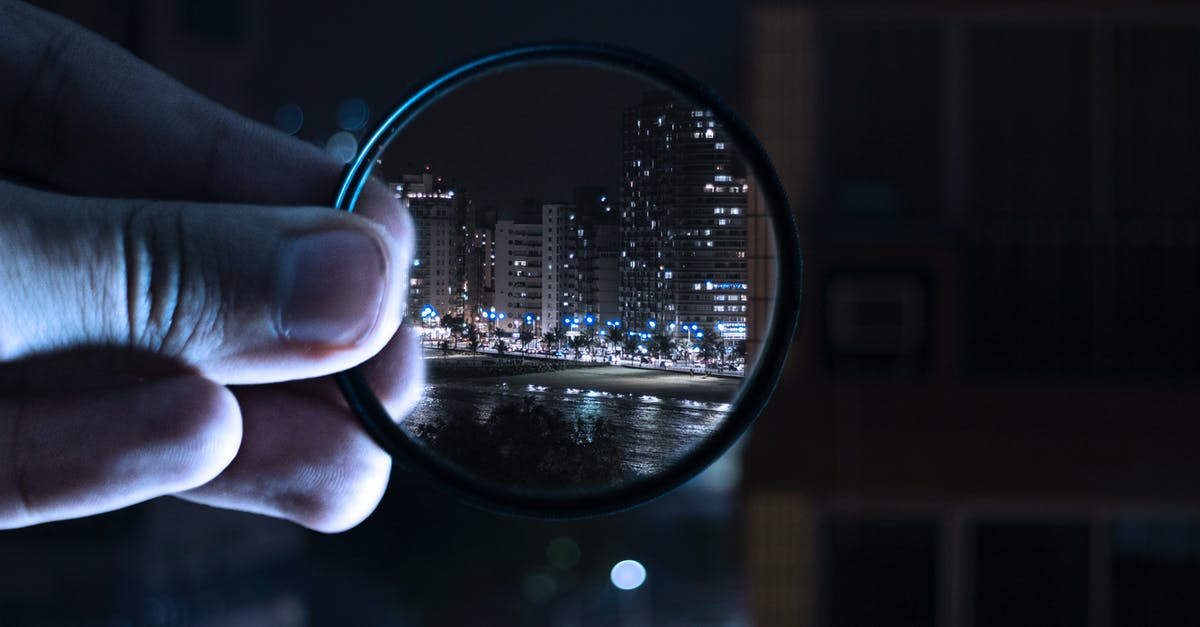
[380,64,654,216]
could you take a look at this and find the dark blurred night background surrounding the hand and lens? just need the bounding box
[0,0,1200,627]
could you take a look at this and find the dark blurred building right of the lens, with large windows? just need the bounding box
[744,2,1200,627]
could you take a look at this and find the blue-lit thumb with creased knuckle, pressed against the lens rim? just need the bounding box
[0,176,409,383]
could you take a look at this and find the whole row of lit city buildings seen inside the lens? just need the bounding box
[391,91,749,353]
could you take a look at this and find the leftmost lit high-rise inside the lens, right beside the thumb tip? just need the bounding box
[391,168,464,317]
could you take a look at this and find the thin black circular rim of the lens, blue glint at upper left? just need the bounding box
[334,42,802,519]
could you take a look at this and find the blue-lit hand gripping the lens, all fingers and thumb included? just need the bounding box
[0,0,421,531]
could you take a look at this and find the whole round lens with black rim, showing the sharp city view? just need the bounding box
[335,43,800,518]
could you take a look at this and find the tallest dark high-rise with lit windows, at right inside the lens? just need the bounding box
[619,92,749,339]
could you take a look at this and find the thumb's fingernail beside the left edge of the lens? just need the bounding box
[278,231,386,346]
